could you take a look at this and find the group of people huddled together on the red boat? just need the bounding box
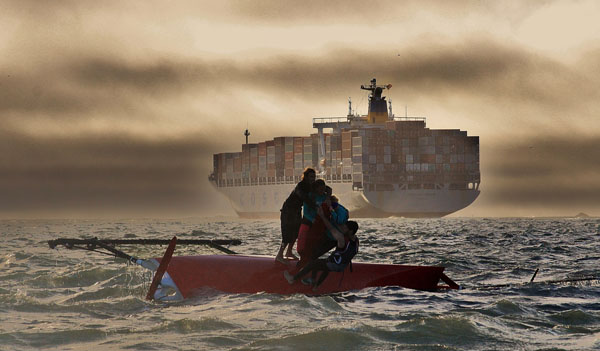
[275,168,358,291]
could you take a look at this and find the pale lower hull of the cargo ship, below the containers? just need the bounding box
[211,183,479,218]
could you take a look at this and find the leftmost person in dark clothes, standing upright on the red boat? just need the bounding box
[275,167,317,264]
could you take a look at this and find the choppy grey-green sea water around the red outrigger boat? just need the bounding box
[0,218,600,351]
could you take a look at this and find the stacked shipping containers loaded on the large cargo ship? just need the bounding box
[212,120,479,190]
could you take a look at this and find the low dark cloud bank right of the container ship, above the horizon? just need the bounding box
[482,136,600,208]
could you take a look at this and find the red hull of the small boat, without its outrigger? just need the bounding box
[157,255,458,298]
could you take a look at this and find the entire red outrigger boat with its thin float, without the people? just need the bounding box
[48,237,459,301]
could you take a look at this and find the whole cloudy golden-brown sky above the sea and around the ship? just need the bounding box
[0,0,600,218]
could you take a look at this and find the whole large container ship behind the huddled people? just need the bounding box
[209,79,481,218]
